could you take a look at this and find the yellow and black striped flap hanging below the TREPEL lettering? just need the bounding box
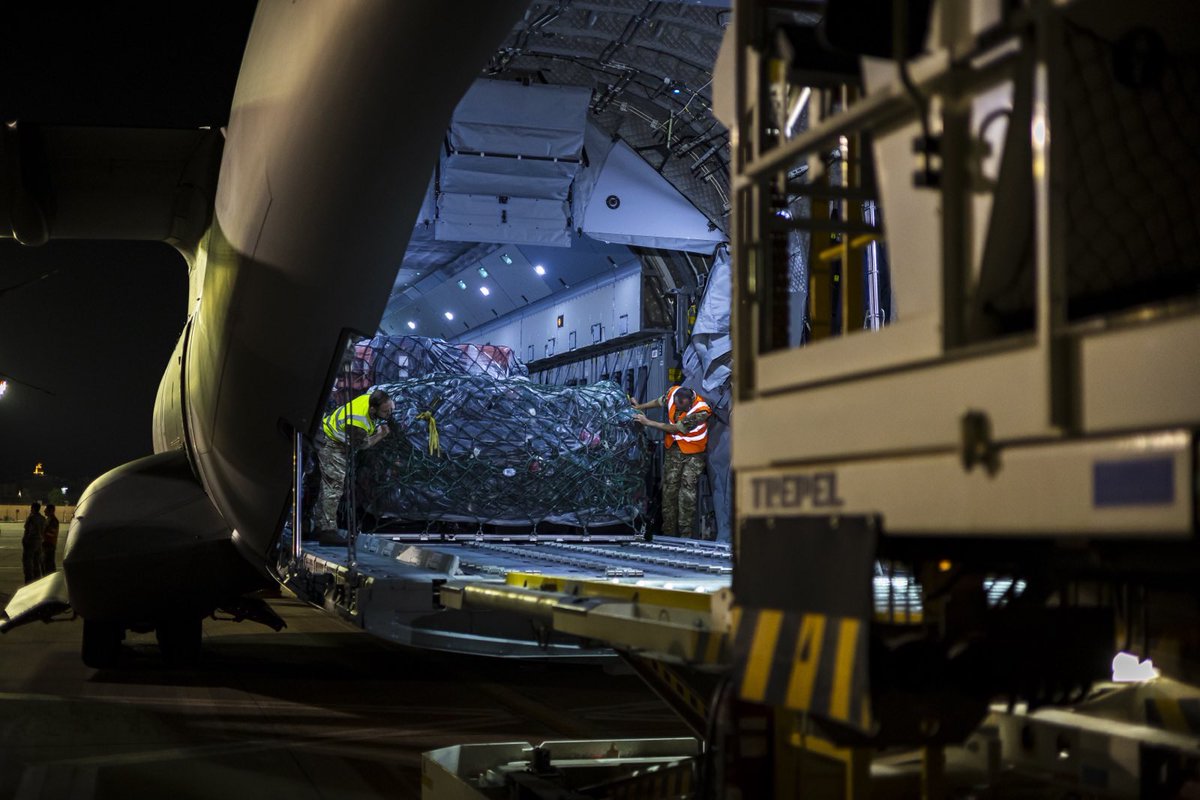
[732,607,871,732]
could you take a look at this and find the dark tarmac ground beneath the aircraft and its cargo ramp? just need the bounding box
[0,524,689,800]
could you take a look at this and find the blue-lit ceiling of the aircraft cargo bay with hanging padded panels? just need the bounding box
[380,0,732,338]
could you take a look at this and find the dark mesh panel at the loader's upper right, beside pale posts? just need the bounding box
[1054,25,1200,319]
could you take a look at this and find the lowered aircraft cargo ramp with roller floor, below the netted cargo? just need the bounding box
[281,534,732,658]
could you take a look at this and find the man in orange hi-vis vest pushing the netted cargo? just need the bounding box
[632,386,713,537]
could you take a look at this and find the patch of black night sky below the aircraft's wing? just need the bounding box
[0,240,187,482]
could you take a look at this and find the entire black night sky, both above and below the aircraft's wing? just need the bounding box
[0,0,254,481]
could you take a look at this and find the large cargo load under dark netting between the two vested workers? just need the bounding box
[358,374,648,528]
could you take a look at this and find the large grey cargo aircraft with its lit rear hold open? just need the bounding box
[0,0,730,666]
